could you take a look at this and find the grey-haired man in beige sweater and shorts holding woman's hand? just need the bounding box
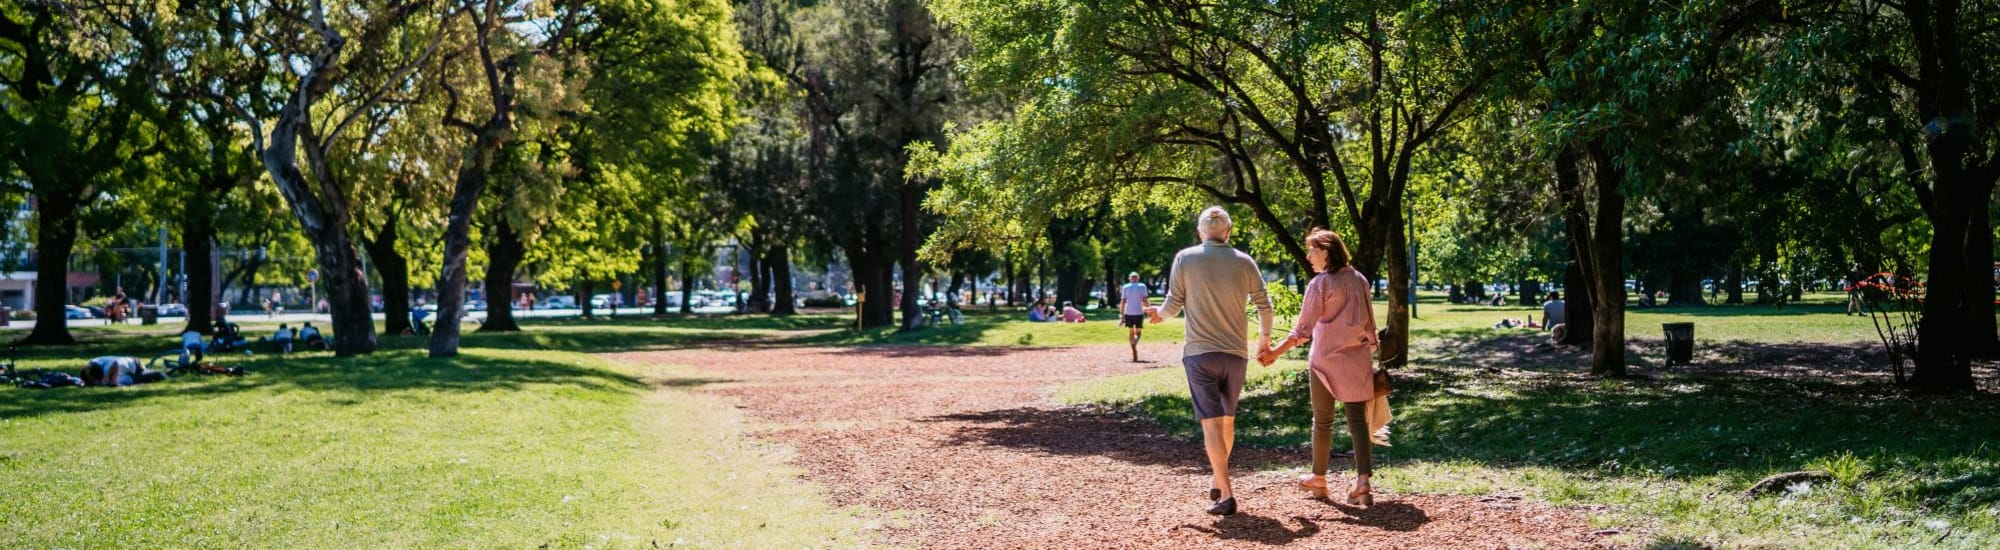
[1146,206,1272,516]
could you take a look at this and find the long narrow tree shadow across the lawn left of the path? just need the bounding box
[0,350,644,418]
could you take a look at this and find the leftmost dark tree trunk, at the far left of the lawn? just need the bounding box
[20,196,78,346]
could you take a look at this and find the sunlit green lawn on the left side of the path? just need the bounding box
[0,336,860,548]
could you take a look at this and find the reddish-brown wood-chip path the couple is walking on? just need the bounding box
[626,344,1598,548]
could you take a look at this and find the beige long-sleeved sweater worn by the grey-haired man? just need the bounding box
[1160,242,1272,358]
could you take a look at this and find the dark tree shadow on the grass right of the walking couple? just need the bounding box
[1080,332,2000,510]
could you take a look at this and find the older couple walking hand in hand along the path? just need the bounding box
[1146,206,1378,516]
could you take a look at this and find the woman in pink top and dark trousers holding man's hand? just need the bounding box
[1258,230,1380,506]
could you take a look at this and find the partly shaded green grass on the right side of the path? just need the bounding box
[1056,334,2000,548]
